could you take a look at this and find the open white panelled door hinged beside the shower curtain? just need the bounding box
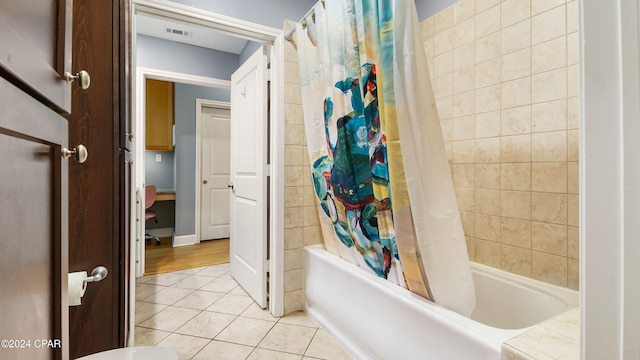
[229,46,268,308]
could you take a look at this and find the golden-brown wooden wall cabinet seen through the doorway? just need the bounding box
[145,79,174,151]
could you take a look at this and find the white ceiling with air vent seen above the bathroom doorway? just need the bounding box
[136,14,247,54]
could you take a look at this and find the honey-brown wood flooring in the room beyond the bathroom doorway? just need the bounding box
[144,238,229,275]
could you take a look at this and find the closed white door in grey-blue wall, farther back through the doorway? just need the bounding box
[200,107,231,240]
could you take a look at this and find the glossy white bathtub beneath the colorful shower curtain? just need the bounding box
[304,245,578,360]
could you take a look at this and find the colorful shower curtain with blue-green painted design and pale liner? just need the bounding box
[294,0,475,316]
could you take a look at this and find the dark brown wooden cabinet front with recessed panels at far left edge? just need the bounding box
[0,0,71,359]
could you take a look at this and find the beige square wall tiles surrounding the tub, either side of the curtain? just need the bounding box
[284,0,579,313]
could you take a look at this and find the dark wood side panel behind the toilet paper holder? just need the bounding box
[69,0,129,358]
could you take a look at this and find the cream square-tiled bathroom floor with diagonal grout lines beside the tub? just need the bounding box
[135,264,351,360]
